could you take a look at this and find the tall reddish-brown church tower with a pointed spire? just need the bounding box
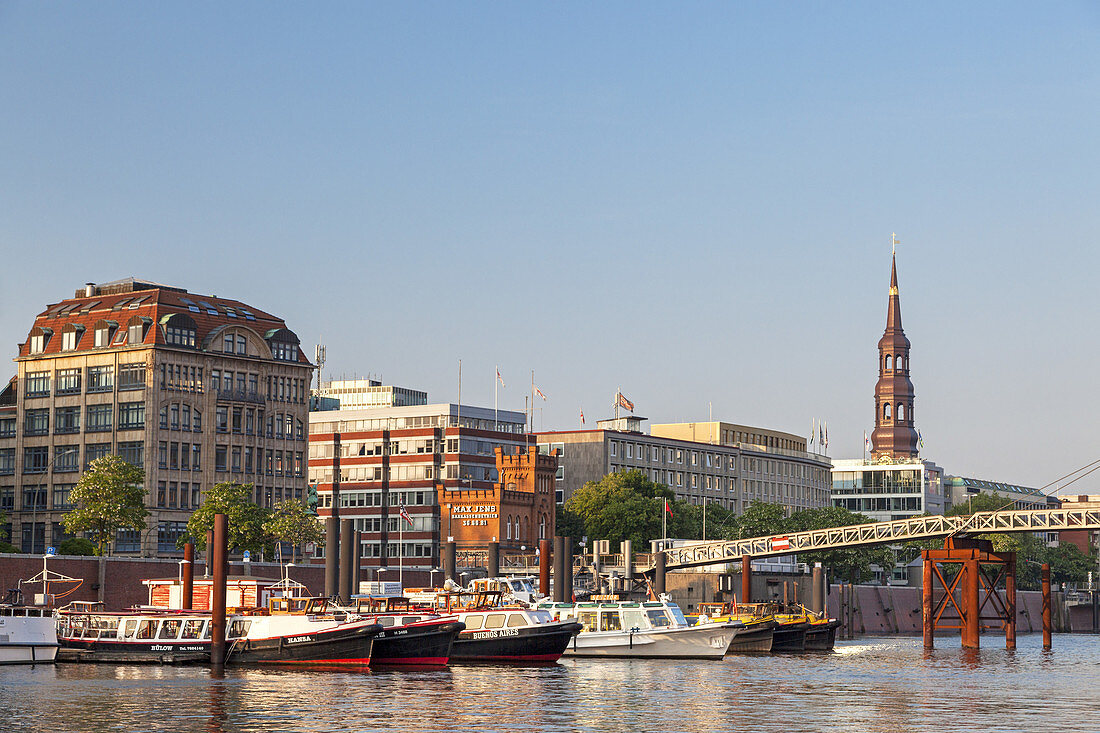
[871,248,917,460]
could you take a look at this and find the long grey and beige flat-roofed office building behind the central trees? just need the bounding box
[537,416,831,512]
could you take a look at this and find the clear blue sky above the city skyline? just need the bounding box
[0,1,1100,493]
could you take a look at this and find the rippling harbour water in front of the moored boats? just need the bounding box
[0,635,1100,733]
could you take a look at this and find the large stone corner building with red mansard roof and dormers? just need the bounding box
[0,278,312,555]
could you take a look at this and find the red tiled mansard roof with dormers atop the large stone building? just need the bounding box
[19,280,309,363]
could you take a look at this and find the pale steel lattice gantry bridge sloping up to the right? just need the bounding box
[664,508,1100,570]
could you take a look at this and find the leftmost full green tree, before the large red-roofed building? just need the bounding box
[62,456,149,556]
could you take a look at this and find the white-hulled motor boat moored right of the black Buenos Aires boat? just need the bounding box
[538,598,745,659]
